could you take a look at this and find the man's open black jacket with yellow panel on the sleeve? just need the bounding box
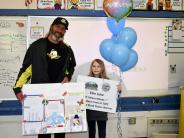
[13,38,76,94]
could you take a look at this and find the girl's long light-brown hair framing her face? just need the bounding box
[88,59,109,79]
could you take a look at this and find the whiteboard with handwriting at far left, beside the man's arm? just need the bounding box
[0,17,27,99]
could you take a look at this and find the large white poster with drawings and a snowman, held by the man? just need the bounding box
[22,83,87,135]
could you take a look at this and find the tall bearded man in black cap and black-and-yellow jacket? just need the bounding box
[13,17,76,138]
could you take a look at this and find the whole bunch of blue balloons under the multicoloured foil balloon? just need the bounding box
[100,17,138,72]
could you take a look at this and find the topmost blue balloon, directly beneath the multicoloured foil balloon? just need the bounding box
[107,17,125,35]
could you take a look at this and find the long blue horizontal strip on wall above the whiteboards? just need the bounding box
[0,9,184,18]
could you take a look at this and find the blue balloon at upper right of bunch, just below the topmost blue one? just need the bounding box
[117,27,137,48]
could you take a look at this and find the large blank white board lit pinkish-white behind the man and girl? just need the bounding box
[28,16,171,91]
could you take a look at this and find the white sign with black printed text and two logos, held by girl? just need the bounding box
[77,75,119,113]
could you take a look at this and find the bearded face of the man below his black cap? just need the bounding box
[50,24,66,42]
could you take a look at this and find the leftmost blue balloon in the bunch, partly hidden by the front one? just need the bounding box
[100,39,114,62]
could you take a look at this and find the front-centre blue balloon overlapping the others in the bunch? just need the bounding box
[111,44,130,67]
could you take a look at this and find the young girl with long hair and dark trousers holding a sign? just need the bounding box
[86,59,121,138]
